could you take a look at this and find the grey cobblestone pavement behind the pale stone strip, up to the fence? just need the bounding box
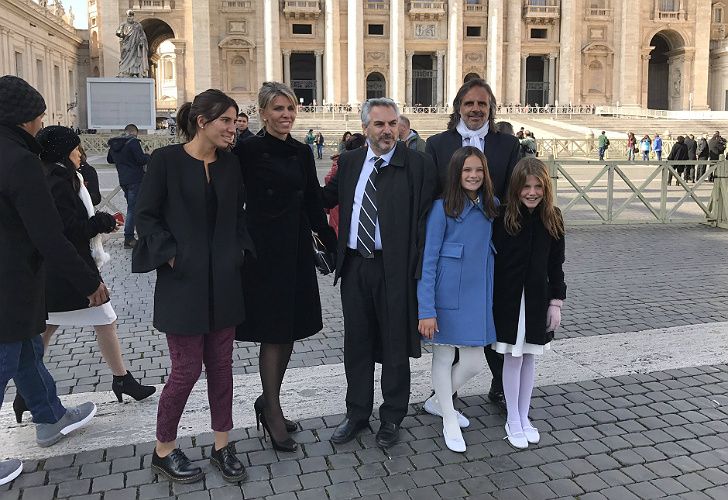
[8,224,728,396]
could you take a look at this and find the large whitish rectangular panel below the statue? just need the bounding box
[86,78,157,130]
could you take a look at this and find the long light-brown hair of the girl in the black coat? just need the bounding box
[504,157,564,239]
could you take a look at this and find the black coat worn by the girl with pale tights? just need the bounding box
[493,206,566,345]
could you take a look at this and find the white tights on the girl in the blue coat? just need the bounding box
[432,344,485,436]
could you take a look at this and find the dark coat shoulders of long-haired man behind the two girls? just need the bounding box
[425,129,521,201]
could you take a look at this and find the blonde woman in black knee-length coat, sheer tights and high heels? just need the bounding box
[234,82,336,451]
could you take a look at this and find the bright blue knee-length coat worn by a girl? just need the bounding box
[417,199,496,346]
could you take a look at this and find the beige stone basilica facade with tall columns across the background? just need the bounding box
[0,0,728,127]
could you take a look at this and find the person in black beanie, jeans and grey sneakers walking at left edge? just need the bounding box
[0,75,109,484]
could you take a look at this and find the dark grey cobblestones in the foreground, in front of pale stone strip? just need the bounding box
[0,365,728,500]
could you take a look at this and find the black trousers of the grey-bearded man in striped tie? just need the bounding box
[341,250,410,425]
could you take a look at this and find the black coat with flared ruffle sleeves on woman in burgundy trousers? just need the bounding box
[132,144,252,335]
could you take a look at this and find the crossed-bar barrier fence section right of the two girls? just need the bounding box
[544,157,726,224]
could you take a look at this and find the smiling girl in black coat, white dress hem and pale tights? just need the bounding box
[491,158,566,448]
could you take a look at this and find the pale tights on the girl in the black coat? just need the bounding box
[503,353,536,433]
